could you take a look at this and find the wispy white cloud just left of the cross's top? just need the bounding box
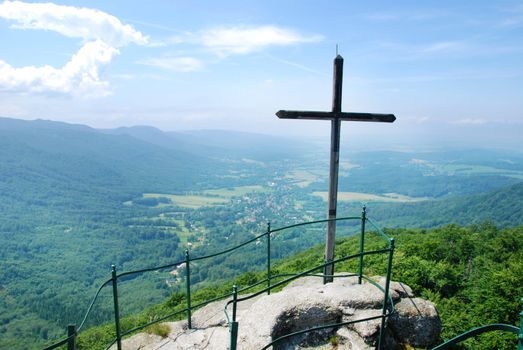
[199,26,322,57]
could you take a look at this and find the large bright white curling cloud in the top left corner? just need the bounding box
[0,1,148,97]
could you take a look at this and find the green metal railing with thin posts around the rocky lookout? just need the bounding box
[44,207,523,350]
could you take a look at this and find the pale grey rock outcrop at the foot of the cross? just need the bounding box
[114,277,441,350]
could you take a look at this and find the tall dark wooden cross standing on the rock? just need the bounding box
[276,55,396,283]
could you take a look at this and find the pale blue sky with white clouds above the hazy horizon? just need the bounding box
[0,0,523,149]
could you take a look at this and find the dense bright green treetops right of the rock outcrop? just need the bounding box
[364,224,523,349]
